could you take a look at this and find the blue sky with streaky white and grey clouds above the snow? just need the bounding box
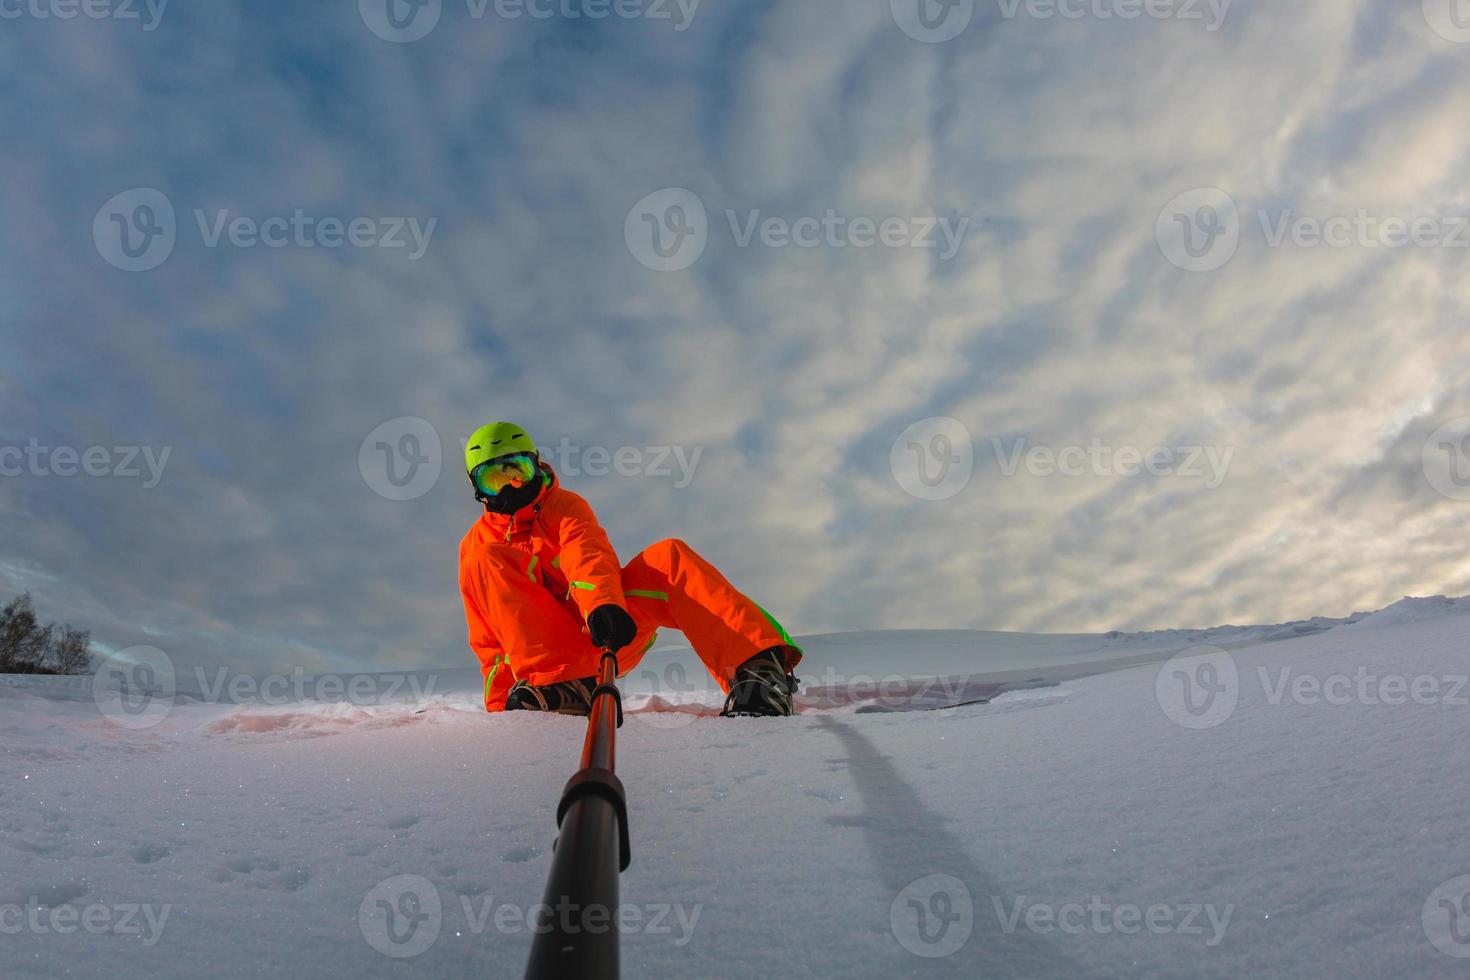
[0,0,1470,671]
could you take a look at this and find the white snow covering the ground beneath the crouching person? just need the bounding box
[0,599,1470,980]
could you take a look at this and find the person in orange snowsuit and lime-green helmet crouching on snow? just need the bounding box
[460,422,801,717]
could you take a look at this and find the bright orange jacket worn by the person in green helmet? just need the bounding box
[459,463,628,693]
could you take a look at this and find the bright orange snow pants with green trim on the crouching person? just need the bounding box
[466,539,801,711]
